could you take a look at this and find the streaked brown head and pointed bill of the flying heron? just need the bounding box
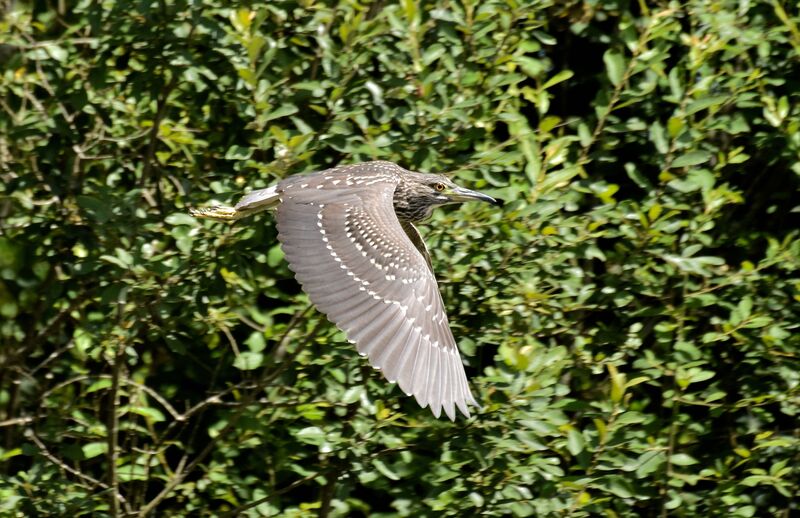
[394,173,503,222]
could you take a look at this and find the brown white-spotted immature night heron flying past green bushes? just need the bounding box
[192,161,501,420]
